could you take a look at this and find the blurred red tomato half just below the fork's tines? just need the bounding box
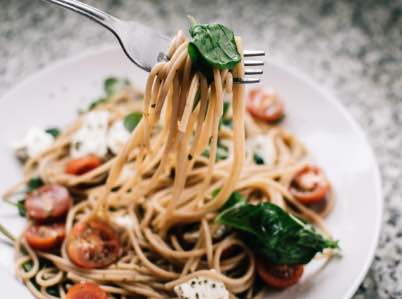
[246,88,285,123]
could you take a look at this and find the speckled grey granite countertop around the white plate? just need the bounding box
[0,0,402,299]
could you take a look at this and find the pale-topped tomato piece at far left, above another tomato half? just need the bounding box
[25,185,73,221]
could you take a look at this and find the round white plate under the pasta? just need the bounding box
[0,48,382,299]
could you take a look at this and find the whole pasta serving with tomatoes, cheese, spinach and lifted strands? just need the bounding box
[2,24,338,299]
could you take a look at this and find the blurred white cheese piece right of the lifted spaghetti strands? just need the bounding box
[246,135,276,165]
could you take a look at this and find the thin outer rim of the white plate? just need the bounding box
[0,44,385,299]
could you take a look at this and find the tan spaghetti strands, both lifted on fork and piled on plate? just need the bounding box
[6,28,333,298]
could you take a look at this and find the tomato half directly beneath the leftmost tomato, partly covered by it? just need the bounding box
[24,223,66,250]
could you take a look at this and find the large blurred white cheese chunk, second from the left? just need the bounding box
[70,111,109,159]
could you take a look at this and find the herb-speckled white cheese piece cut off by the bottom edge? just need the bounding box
[174,276,229,299]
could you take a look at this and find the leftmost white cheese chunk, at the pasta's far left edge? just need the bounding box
[13,128,55,160]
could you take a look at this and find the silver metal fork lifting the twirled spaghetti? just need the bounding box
[43,0,265,84]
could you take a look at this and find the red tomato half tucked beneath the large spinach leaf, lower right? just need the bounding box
[257,259,304,289]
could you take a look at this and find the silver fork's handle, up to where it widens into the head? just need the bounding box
[43,0,119,33]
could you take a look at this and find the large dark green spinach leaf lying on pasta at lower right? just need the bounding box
[217,202,338,265]
